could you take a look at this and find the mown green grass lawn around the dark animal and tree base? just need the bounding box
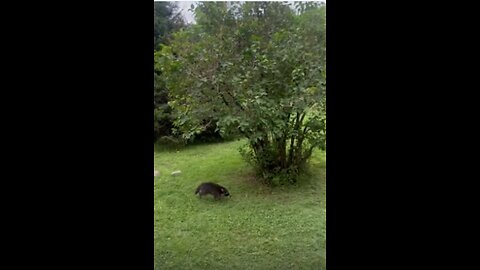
[154,141,326,270]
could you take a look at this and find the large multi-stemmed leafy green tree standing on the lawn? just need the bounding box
[159,2,326,184]
